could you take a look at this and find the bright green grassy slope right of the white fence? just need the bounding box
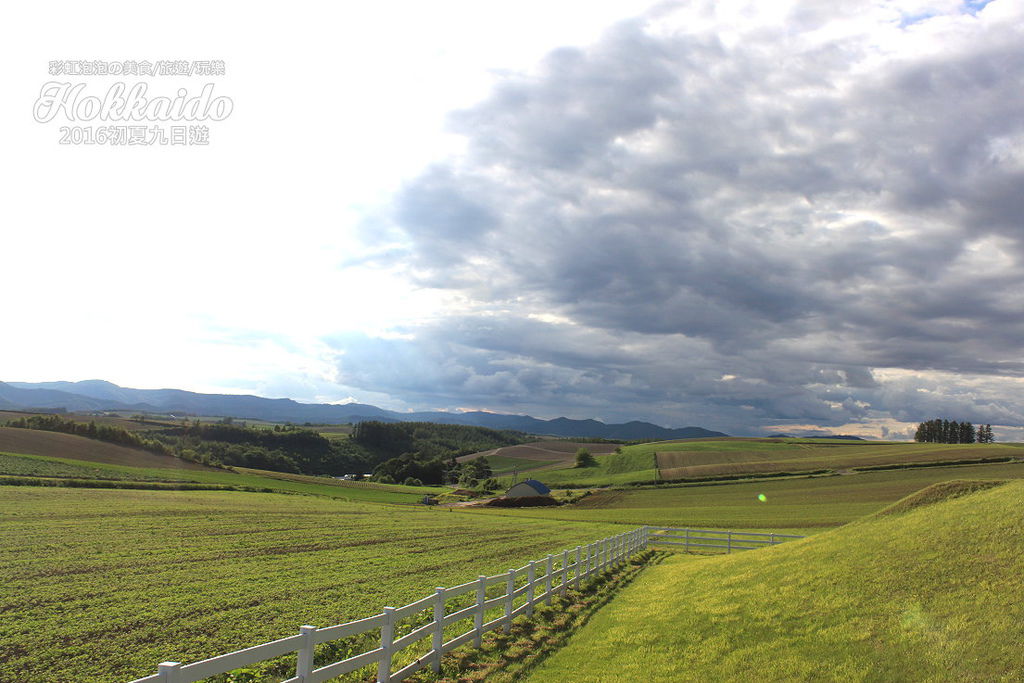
[528,481,1024,681]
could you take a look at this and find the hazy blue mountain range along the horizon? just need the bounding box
[0,380,726,439]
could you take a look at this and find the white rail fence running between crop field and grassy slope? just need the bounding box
[131,526,803,683]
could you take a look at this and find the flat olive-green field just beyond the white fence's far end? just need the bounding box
[473,463,1024,530]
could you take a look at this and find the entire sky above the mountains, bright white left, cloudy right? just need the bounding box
[0,0,1024,440]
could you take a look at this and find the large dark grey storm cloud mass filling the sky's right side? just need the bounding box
[333,0,1024,430]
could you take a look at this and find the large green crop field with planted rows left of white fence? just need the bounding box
[0,487,622,683]
